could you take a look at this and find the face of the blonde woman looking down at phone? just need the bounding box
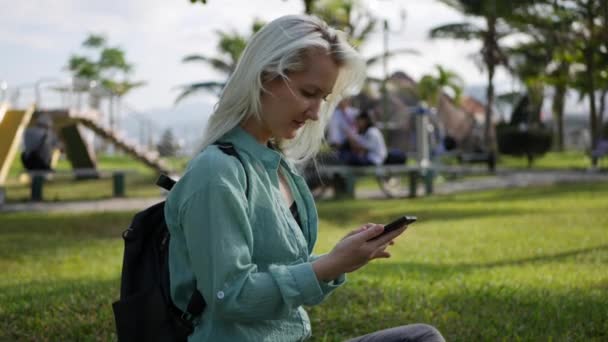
[252,50,339,142]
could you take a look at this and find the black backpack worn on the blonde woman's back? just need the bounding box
[112,143,242,342]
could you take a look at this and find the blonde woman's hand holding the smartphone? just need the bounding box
[312,223,406,282]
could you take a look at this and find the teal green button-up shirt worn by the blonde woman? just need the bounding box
[165,127,345,342]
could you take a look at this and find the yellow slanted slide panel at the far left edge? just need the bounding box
[0,103,34,185]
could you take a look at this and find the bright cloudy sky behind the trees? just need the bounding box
[0,0,583,138]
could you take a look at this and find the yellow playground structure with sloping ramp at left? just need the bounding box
[0,78,170,186]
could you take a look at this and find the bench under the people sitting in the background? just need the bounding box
[306,165,434,198]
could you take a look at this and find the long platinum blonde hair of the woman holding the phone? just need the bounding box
[201,15,365,162]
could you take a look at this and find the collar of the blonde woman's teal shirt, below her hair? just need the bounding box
[220,125,281,170]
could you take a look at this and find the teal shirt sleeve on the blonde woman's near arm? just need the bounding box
[180,173,329,321]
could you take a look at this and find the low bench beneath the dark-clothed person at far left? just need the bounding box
[28,169,129,202]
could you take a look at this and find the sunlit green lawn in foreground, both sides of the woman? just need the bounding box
[0,183,608,341]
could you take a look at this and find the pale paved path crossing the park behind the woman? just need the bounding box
[0,171,608,213]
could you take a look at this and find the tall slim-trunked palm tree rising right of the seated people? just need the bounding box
[429,0,526,152]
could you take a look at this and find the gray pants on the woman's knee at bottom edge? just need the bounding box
[348,324,445,342]
